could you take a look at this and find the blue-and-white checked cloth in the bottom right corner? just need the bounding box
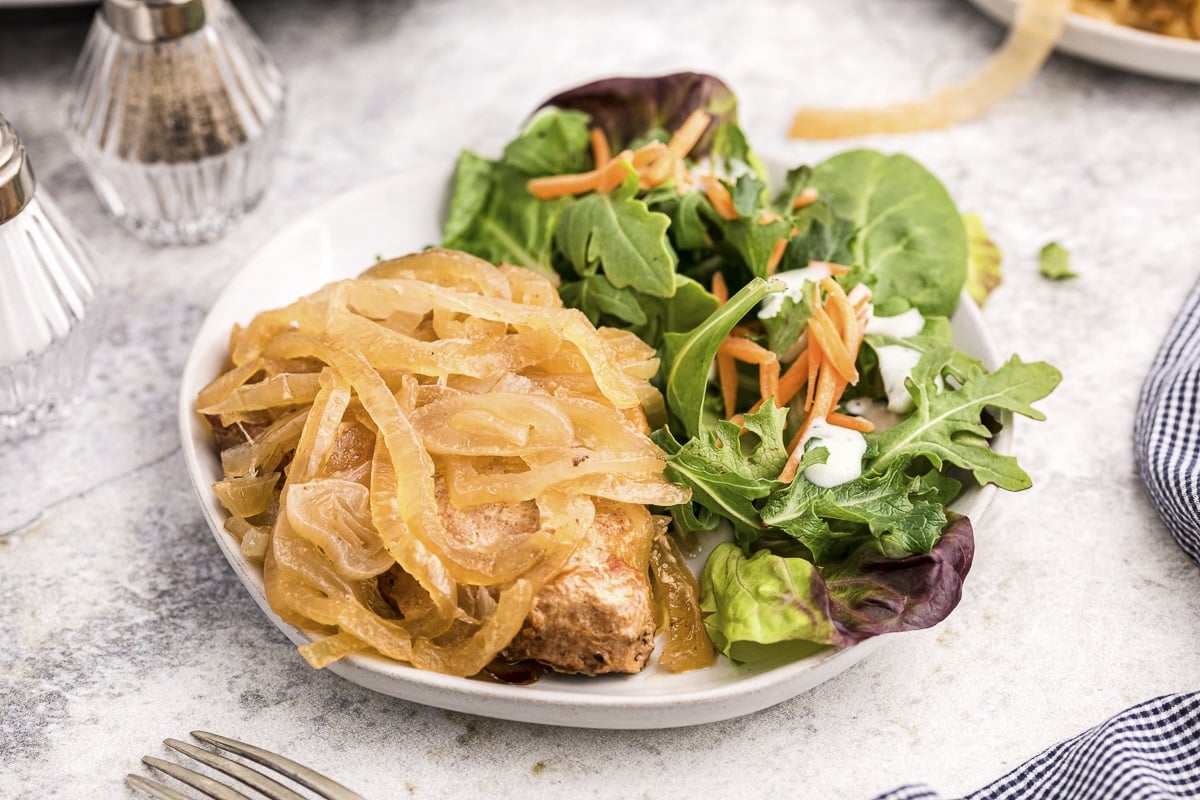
[876,692,1200,800]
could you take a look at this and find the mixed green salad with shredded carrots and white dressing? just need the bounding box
[443,73,1061,661]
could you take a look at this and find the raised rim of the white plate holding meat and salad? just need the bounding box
[178,162,1013,729]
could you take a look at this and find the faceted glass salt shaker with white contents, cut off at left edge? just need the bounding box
[0,116,102,441]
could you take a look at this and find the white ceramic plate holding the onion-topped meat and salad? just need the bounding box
[179,164,1012,728]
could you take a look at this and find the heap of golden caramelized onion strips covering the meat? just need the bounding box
[197,251,698,675]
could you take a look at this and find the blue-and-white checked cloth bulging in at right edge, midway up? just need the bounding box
[1133,283,1200,561]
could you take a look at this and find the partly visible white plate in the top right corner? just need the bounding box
[971,0,1200,83]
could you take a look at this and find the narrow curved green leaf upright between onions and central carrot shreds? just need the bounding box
[662,278,781,437]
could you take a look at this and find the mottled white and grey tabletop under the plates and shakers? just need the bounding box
[0,0,1200,800]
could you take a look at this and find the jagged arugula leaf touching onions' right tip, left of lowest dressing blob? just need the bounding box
[650,403,787,542]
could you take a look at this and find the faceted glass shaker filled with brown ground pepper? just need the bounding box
[67,0,284,245]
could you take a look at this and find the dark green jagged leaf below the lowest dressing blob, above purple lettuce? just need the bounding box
[762,464,946,564]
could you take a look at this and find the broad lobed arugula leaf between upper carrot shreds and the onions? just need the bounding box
[554,169,676,297]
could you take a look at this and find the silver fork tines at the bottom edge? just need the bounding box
[125,730,366,800]
